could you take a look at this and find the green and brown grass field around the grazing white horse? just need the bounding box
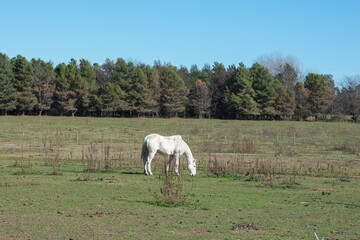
[0,117,360,239]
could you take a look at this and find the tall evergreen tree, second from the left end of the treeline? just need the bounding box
[11,55,37,115]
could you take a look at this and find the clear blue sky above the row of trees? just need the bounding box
[0,0,360,83]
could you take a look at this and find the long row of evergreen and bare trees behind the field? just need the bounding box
[0,53,360,120]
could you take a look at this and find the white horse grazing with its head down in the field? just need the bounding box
[141,134,196,176]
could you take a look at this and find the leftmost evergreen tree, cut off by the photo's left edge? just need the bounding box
[0,53,17,116]
